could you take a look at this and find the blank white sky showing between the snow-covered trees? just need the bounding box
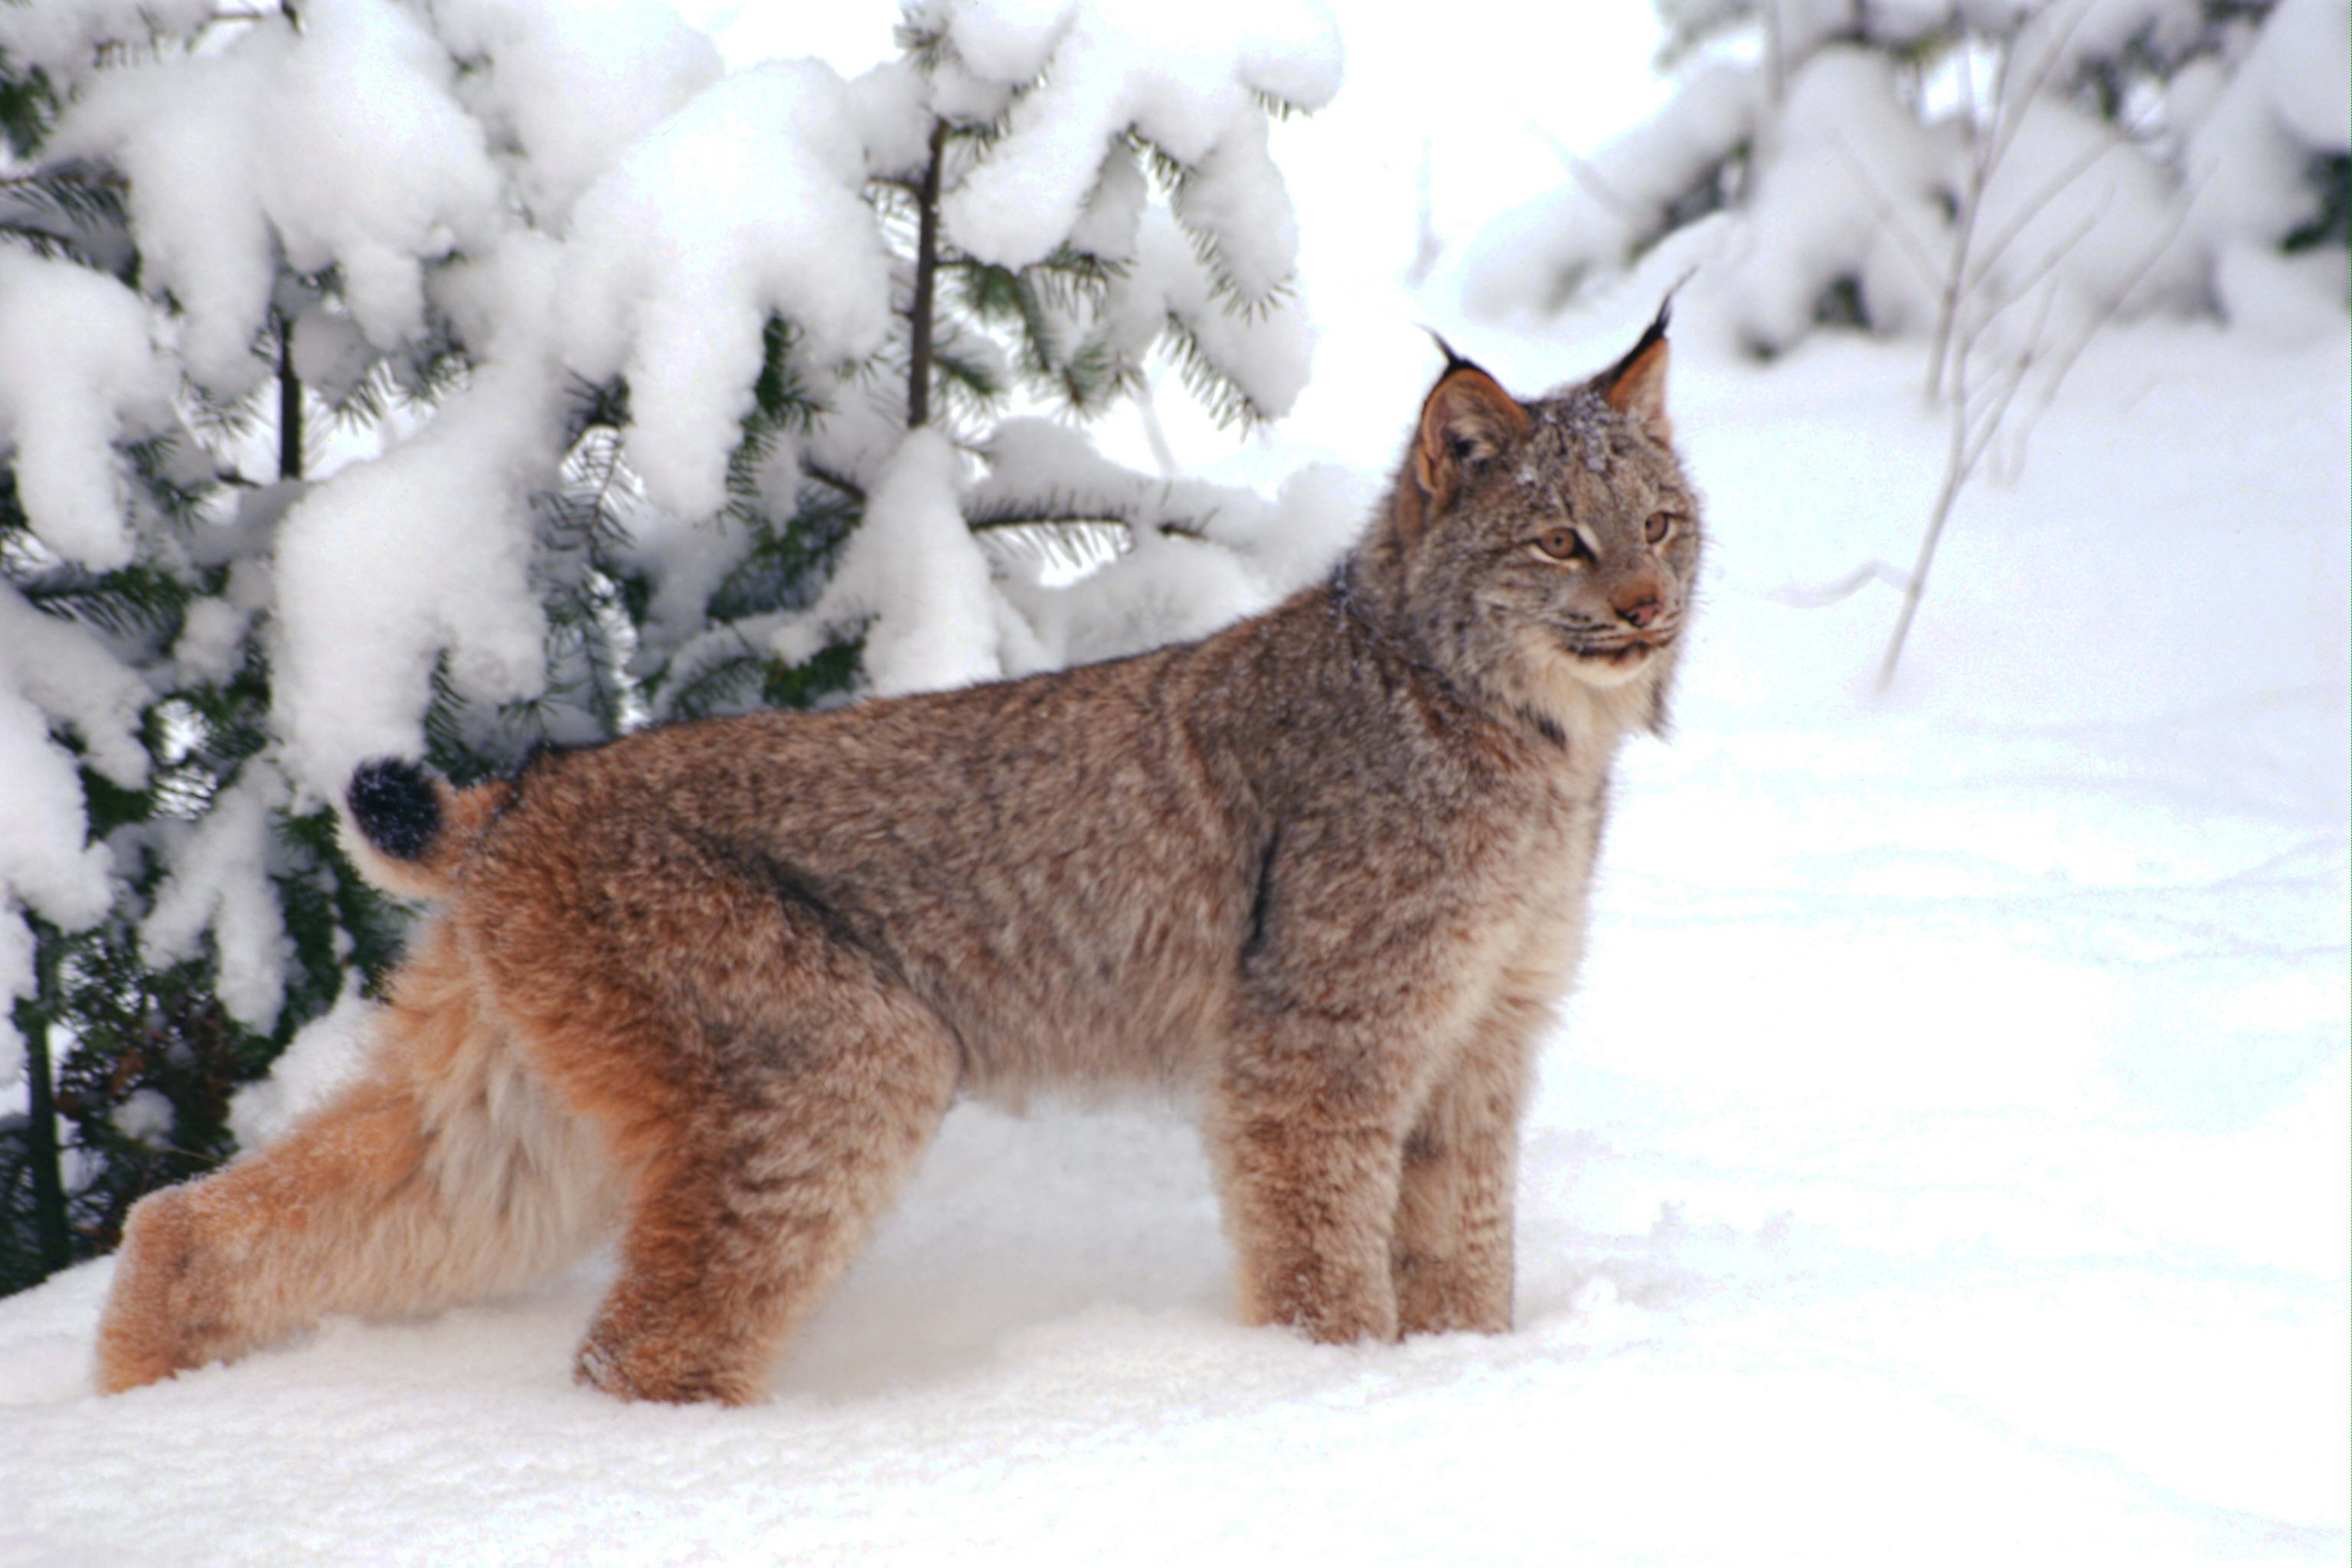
[654,0,1670,475]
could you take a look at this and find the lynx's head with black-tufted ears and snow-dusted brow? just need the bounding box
[1357,308,1700,738]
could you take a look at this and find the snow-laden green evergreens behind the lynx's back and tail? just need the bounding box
[0,0,1345,1291]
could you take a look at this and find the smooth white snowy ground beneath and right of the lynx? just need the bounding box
[0,303,2352,1563]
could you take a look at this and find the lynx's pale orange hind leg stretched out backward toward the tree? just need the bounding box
[96,931,612,1394]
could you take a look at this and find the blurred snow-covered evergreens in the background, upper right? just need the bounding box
[1456,0,2352,353]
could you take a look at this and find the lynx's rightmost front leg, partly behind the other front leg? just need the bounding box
[1390,1004,1545,1333]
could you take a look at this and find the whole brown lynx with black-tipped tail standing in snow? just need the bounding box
[96,308,1700,1403]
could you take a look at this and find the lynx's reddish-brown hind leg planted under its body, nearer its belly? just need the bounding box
[562,930,959,1403]
